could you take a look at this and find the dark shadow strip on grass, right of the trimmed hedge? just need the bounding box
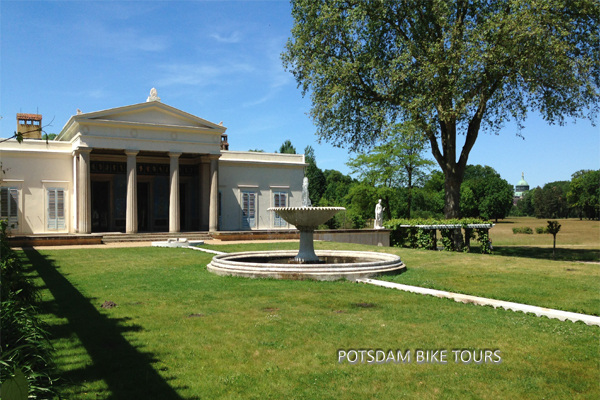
[471,246,600,261]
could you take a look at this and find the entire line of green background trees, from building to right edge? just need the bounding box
[276,140,600,225]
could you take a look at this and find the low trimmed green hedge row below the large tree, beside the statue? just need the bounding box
[383,218,492,254]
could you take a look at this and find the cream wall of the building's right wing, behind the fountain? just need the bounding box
[219,152,305,231]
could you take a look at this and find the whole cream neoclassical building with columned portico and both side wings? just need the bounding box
[0,90,306,235]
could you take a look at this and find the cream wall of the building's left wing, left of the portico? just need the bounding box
[0,140,73,234]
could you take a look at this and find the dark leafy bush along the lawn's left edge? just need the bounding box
[0,220,57,399]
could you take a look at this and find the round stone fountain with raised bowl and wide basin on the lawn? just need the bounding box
[207,177,406,280]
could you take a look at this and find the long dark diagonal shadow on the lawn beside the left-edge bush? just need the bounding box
[24,250,188,400]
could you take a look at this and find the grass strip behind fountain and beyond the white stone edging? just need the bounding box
[206,242,600,315]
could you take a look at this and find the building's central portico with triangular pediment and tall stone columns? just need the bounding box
[57,91,227,234]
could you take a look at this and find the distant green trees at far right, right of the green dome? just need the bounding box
[512,170,600,219]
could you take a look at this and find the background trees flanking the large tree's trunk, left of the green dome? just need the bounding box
[279,141,513,229]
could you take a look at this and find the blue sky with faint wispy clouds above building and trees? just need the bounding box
[0,0,600,187]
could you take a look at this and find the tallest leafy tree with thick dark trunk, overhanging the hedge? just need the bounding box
[282,0,600,218]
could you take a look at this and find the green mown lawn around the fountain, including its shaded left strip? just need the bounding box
[20,243,600,399]
